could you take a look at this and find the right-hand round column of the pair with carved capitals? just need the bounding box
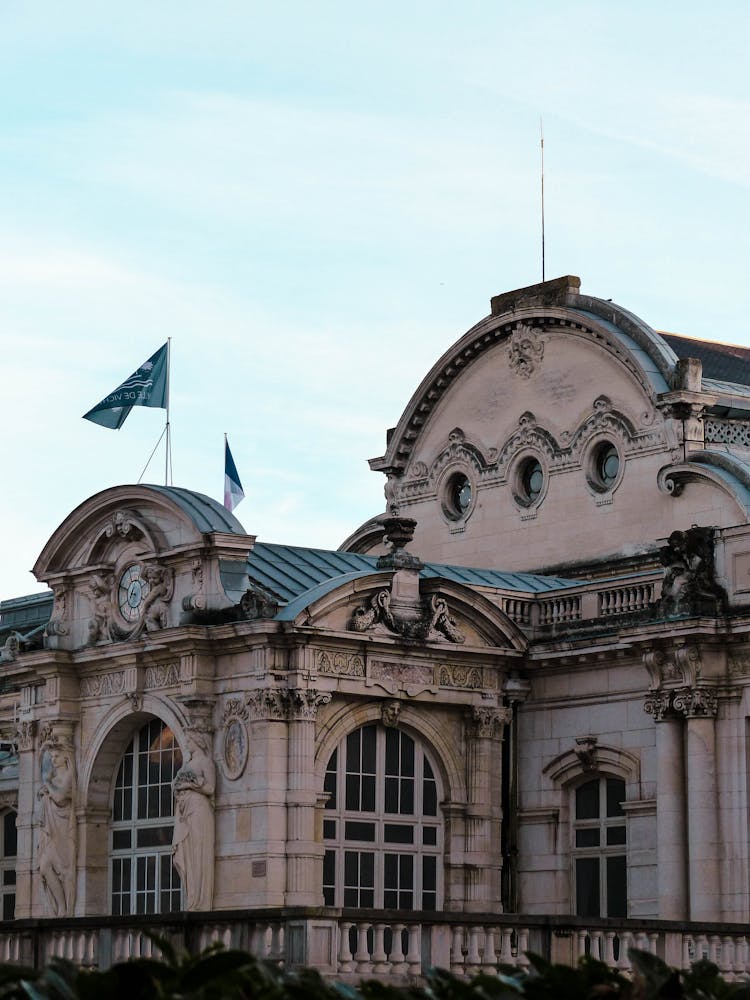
[672,687,721,920]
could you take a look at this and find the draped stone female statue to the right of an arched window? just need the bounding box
[172,730,216,910]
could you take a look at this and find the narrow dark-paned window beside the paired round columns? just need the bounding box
[573,776,628,917]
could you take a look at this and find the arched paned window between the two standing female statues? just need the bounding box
[110,719,182,915]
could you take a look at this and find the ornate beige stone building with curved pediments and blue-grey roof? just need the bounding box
[0,277,750,972]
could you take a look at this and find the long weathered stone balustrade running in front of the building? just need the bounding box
[0,909,750,983]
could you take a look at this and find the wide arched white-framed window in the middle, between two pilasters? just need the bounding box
[323,724,443,910]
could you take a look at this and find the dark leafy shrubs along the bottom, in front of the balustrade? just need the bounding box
[0,938,750,1000]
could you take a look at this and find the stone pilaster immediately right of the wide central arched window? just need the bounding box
[465,706,511,912]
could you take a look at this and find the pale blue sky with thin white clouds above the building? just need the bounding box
[0,0,750,598]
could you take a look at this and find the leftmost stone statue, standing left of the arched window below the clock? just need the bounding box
[37,736,77,917]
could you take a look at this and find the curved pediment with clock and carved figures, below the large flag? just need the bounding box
[34,486,254,649]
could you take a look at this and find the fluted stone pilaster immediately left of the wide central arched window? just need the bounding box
[285,688,331,906]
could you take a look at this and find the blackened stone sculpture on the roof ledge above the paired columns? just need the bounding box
[659,527,727,618]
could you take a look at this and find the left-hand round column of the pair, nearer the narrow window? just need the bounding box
[645,692,688,920]
